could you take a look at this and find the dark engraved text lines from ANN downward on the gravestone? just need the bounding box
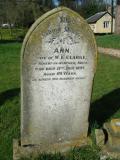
[32,48,88,81]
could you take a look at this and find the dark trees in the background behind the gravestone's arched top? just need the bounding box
[0,0,106,27]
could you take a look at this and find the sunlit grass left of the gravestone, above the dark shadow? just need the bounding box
[0,43,21,92]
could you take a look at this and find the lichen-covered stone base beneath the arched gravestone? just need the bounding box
[13,137,90,160]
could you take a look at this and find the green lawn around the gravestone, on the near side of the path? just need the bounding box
[0,43,120,160]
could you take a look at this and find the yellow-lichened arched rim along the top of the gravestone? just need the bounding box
[21,6,97,70]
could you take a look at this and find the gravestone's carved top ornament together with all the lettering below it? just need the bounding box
[32,16,88,82]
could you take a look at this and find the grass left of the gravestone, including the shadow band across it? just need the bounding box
[0,43,21,160]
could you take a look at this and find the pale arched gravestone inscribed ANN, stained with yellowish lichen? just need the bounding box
[14,7,97,159]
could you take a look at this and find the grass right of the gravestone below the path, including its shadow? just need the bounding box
[90,55,120,126]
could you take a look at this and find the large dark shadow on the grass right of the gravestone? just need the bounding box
[89,88,120,131]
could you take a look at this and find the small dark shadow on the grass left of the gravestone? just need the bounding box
[0,88,20,105]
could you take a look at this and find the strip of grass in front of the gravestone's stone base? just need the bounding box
[21,146,100,160]
